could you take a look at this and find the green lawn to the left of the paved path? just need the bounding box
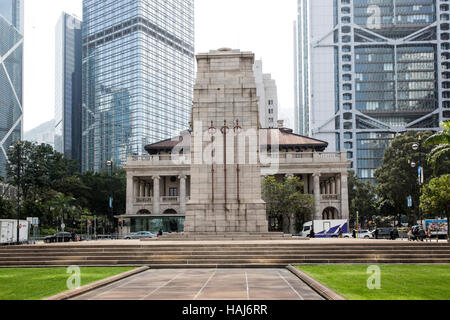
[0,267,134,300]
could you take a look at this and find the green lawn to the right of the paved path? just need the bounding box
[298,265,450,300]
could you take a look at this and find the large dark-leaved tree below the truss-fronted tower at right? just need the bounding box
[375,131,432,223]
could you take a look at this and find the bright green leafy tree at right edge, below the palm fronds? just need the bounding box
[420,174,450,239]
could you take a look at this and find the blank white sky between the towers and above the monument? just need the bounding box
[24,0,297,131]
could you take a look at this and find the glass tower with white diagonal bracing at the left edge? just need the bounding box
[0,0,24,176]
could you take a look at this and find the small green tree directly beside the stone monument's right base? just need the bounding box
[262,176,314,233]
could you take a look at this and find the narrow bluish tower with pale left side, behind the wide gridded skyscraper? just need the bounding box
[54,12,82,163]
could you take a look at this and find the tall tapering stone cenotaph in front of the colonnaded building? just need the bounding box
[185,49,268,233]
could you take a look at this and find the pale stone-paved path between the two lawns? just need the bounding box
[73,269,323,300]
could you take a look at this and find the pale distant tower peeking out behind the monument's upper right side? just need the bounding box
[253,60,278,128]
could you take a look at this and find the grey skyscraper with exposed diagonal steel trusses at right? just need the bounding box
[298,0,450,182]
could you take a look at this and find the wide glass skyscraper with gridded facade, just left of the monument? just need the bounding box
[82,0,194,171]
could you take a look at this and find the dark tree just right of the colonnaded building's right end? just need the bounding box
[348,171,378,228]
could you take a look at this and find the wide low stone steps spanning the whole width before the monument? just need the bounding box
[0,241,450,268]
